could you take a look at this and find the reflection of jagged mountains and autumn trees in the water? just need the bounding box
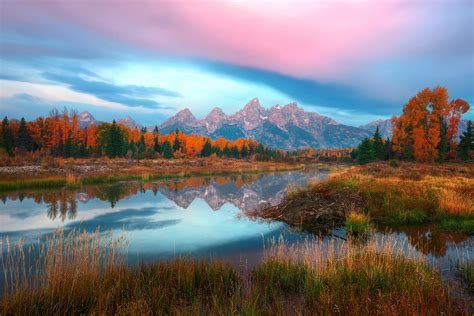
[1,172,324,221]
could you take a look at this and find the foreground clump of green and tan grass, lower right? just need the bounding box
[252,238,459,315]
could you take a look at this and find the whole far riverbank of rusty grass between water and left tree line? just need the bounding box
[0,159,305,192]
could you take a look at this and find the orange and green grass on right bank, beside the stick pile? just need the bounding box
[322,164,474,234]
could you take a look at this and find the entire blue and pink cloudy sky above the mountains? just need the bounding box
[0,0,474,126]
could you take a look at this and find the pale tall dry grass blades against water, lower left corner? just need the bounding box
[0,229,128,298]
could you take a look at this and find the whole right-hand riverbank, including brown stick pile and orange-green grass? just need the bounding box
[251,163,474,235]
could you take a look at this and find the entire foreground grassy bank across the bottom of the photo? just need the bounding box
[0,232,467,315]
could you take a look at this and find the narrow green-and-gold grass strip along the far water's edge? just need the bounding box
[0,164,304,192]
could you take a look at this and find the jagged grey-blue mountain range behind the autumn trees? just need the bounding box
[79,98,466,149]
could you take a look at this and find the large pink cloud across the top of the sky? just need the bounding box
[0,0,424,80]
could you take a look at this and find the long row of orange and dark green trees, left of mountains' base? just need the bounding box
[0,109,283,160]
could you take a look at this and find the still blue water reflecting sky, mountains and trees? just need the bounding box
[0,171,474,275]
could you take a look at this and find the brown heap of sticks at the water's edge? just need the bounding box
[249,185,362,231]
